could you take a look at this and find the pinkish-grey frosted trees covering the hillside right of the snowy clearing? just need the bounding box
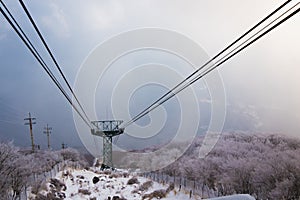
[161,133,300,200]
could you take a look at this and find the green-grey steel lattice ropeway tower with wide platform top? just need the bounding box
[91,120,124,168]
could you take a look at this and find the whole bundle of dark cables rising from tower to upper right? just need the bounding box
[122,0,300,128]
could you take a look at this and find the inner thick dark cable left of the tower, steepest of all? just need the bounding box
[19,0,91,121]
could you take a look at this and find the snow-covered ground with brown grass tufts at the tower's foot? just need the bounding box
[31,169,200,200]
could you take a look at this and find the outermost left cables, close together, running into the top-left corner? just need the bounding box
[0,0,91,128]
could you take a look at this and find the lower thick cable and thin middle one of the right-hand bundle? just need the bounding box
[124,3,300,128]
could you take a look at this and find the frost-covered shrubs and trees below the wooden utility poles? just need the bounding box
[0,143,88,199]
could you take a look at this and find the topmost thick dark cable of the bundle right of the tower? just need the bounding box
[123,0,292,127]
